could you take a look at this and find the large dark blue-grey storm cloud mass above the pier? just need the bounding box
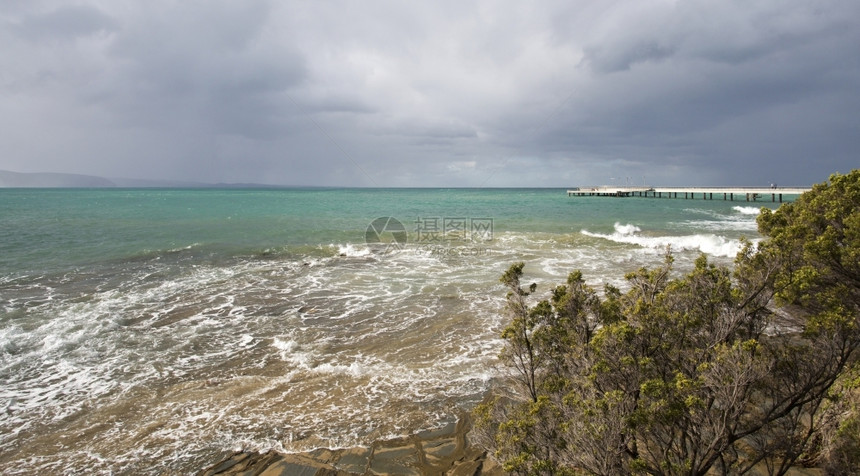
[504,2,860,183]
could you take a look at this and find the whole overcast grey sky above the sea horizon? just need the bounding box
[0,0,860,187]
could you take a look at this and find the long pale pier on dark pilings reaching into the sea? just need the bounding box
[567,185,811,203]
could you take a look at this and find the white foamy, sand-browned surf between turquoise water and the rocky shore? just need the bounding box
[10,228,740,472]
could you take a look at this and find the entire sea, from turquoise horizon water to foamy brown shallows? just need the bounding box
[0,189,778,474]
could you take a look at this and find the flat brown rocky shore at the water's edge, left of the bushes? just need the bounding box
[200,414,504,476]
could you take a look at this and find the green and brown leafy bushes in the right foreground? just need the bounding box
[476,171,860,475]
